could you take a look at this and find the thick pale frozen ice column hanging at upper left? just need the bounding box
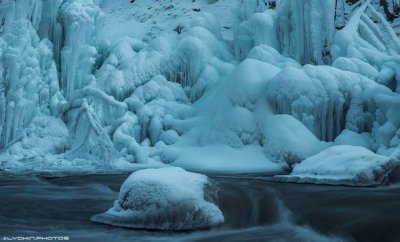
[60,0,103,99]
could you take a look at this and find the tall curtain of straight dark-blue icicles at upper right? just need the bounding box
[277,0,335,64]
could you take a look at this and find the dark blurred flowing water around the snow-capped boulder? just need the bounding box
[0,175,400,242]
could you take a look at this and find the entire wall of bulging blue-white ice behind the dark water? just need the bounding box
[0,0,400,180]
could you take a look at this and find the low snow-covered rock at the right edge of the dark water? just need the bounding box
[273,145,398,186]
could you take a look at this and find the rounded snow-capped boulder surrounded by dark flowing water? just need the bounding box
[91,167,224,230]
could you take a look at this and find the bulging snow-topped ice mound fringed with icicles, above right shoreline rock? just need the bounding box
[267,66,391,141]
